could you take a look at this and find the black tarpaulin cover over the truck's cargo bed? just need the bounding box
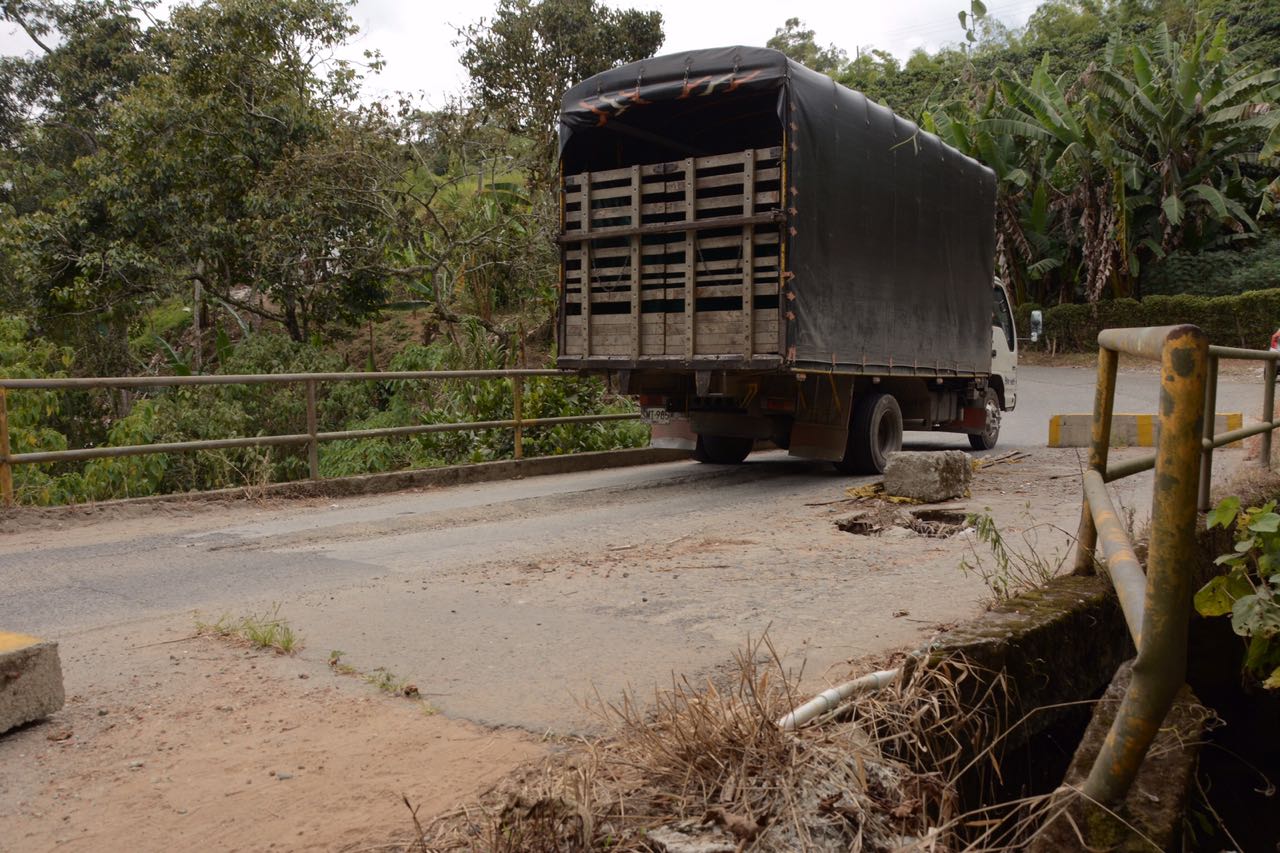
[561,47,996,375]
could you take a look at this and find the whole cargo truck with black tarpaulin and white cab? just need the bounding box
[557,46,1018,474]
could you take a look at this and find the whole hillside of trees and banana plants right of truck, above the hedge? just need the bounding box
[771,0,1280,302]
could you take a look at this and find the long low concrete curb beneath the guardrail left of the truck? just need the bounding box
[0,447,689,519]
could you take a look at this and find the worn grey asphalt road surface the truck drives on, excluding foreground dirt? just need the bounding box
[0,368,1261,731]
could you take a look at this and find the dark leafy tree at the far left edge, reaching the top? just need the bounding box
[0,0,154,365]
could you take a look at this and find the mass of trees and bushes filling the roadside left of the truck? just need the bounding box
[0,0,662,503]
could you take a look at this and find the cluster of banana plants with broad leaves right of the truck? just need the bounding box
[928,23,1280,302]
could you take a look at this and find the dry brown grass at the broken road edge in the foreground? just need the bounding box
[411,640,1004,853]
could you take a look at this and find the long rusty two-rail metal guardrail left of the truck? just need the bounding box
[0,369,640,506]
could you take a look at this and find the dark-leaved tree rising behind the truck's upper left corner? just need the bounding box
[458,0,663,188]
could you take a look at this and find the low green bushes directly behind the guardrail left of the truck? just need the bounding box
[0,316,649,505]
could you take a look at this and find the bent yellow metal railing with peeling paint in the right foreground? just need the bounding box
[1075,325,1280,803]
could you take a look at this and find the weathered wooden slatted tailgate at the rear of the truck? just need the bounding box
[561,147,782,360]
